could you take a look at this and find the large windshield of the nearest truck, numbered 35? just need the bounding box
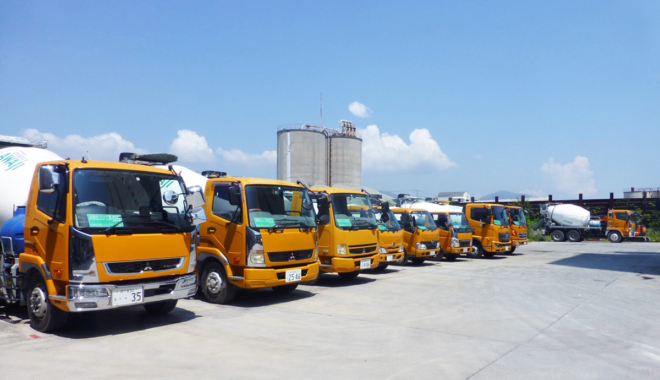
[73,169,194,233]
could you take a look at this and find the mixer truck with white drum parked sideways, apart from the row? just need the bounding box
[534,204,649,243]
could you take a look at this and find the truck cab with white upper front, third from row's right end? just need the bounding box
[431,211,474,261]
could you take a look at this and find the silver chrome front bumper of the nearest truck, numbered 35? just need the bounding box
[61,273,197,312]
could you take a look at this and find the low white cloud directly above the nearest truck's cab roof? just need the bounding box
[21,129,147,161]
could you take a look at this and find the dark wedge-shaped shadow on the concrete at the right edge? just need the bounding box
[548,252,660,275]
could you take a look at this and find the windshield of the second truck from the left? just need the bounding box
[245,185,316,228]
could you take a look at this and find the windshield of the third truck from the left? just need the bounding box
[331,194,376,230]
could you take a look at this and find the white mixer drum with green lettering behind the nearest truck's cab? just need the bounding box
[0,146,62,226]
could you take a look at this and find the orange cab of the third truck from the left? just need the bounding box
[311,187,380,279]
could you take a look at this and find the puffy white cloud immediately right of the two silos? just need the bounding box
[359,125,456,171]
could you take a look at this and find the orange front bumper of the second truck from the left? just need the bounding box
[237,261,319,289]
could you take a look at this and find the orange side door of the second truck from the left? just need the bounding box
[202,182,246,265]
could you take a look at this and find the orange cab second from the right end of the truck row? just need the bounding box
[464,203,511,257]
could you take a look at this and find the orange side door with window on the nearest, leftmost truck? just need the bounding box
[25,166,69,280]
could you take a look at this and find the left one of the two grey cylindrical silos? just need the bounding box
[277,124,328,186]
